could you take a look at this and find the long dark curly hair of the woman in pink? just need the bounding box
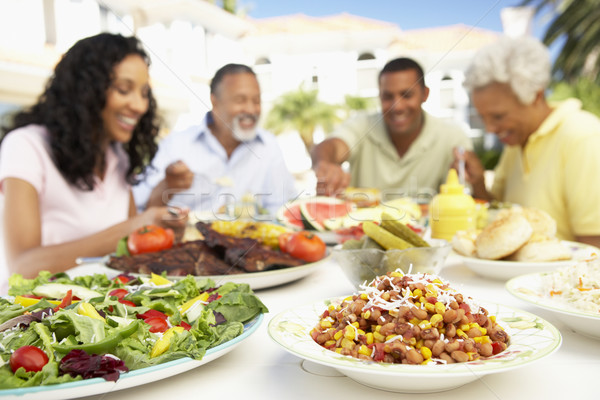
[0,33,159,190]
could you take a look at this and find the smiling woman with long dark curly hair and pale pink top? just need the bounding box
[0,33,187,277]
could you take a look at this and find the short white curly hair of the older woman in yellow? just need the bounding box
[463,36,551,104]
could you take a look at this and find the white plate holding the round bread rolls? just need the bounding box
[458,240,600,280]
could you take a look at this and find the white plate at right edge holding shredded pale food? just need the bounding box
[506,273,600,339]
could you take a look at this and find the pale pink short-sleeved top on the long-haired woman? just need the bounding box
[0,125,130,245]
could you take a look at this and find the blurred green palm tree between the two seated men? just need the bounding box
[265,88,340,152]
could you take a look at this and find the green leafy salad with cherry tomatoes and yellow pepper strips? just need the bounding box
[0,272,268,394]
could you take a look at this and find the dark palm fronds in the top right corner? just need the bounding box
[522,0,600,84]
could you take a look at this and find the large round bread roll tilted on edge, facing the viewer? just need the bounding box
[475,213,533,260]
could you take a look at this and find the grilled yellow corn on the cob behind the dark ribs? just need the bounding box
[210,221,290,249]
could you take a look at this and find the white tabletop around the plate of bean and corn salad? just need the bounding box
[71,255,600,400]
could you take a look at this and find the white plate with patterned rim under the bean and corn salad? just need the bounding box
[268,299,562,393]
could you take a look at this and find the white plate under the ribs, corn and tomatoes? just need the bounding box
[88,255,331,290]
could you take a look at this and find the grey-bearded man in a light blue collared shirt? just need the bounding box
[134,64,296,215]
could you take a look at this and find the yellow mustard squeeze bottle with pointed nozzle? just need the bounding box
[429,169,477,241]
